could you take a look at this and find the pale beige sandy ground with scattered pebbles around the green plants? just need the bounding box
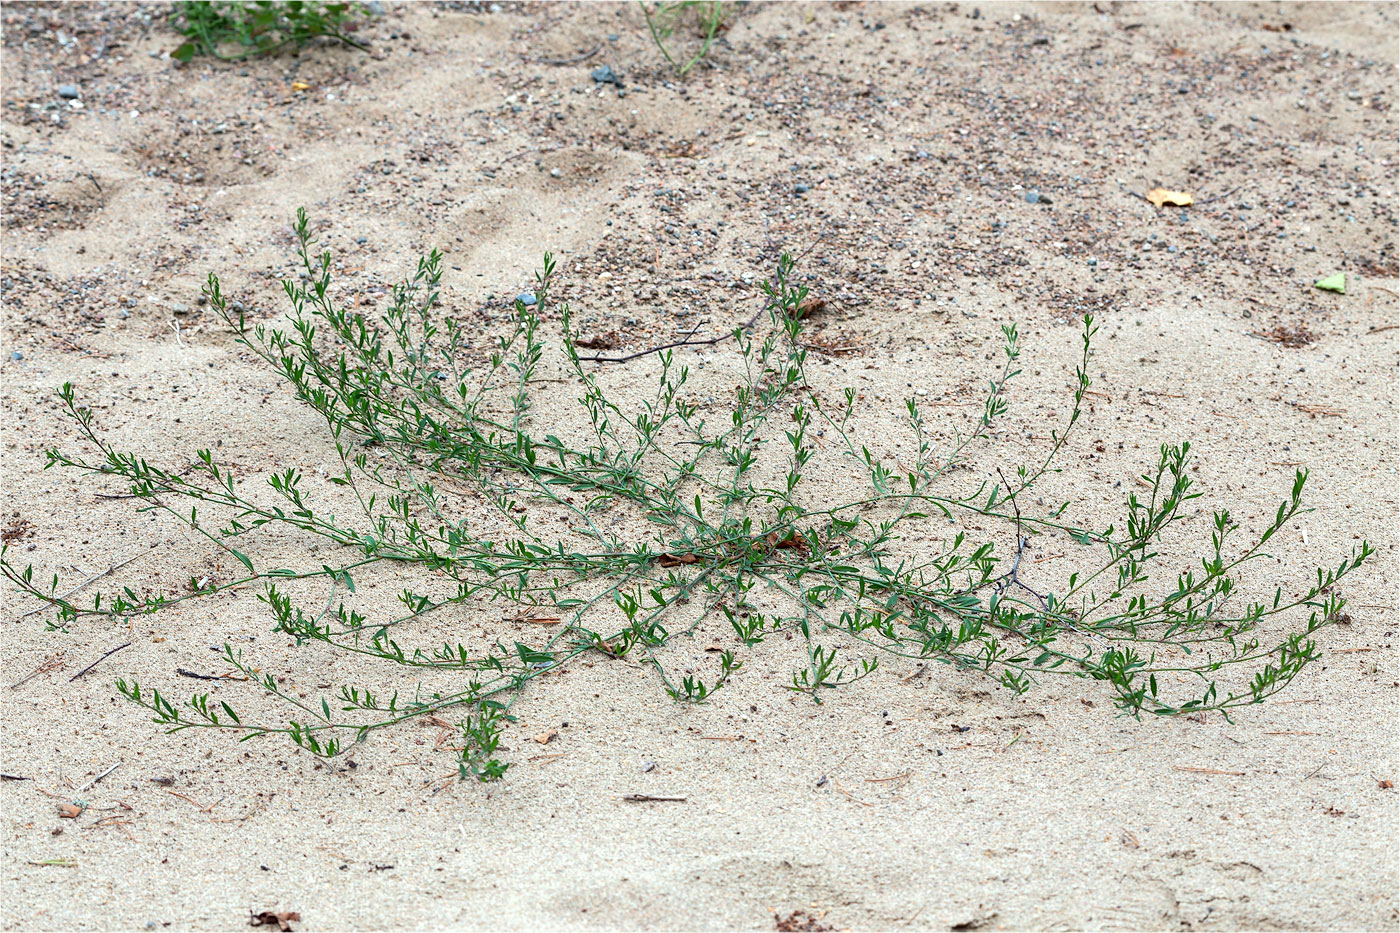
[0,0,1400,930]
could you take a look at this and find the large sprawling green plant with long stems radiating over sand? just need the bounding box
[0,212,1372,779]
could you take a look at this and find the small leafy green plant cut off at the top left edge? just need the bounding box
[171,0,368,62]
